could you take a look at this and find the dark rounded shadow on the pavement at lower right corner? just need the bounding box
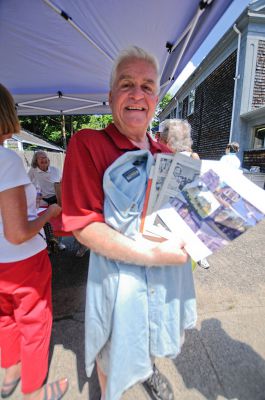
[175,318,265,400]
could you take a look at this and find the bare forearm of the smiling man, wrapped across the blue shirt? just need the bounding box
[74,222,188,266]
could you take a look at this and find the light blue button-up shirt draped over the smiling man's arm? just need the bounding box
[85,150,197,400]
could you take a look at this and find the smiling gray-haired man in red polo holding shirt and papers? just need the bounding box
[62,47,188,400]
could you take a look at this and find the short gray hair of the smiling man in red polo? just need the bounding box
[110,46,159,91]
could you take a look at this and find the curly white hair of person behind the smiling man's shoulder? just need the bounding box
[160,119,192,153]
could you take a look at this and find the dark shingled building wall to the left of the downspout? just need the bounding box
[186,51,236,160]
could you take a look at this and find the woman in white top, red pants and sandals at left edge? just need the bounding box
[0,85,68,400]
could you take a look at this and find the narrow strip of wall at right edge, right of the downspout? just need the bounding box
[252,40,265,109]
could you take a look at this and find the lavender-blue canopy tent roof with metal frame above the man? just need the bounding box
[0,0,233,115]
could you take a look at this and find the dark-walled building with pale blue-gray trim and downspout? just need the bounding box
[159,0,265,172]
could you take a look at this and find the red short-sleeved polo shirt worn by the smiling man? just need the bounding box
[62,124,170,231]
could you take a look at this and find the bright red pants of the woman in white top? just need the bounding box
[0,250,52,394]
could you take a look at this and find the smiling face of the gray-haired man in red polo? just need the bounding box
[109,58,158,141]
